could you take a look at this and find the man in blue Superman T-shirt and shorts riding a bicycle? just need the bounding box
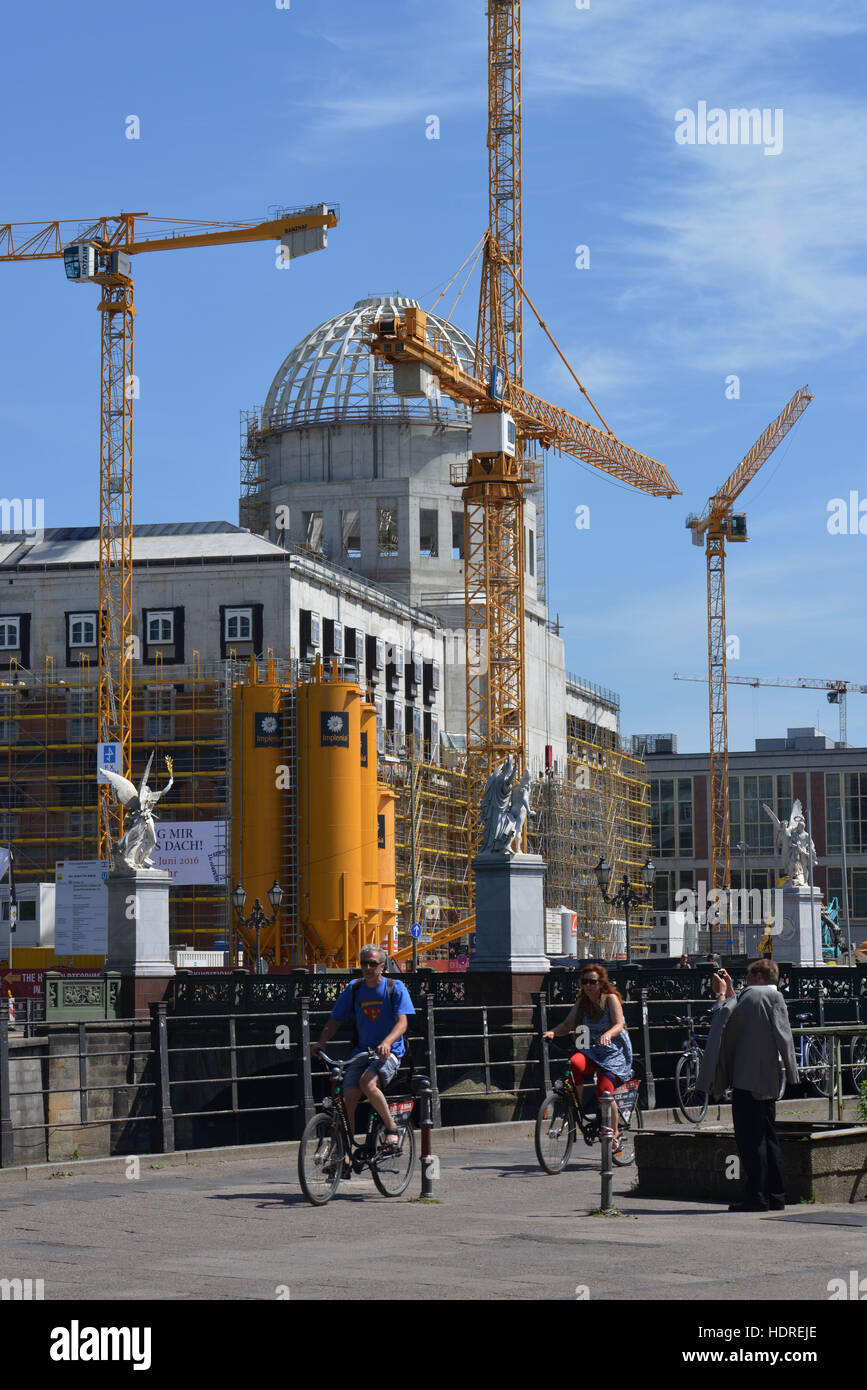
[311,947,415,1148]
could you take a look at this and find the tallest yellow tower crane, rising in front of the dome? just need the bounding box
[368,0,679,885]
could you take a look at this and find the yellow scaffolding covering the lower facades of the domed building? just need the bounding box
[0,652,652,962]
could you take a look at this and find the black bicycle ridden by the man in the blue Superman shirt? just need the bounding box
[299,1048,415,1207]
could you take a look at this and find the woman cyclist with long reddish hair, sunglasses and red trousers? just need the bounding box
[542,965,632,1152]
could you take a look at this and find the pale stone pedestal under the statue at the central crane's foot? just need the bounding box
[470,853,550,988]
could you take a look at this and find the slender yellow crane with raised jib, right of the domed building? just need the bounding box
[686,386,813,888]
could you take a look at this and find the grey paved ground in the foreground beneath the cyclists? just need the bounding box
[0,1125,867,1301]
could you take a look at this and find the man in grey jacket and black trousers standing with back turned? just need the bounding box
[713,960,798,1212]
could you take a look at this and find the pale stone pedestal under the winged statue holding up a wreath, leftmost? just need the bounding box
[106,869,175,1017]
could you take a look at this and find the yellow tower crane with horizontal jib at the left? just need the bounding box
[0,203,338,859]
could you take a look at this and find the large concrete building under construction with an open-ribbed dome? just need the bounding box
[0,296,650,963]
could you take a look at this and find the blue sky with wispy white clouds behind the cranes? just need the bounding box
[0,0,867,751]
